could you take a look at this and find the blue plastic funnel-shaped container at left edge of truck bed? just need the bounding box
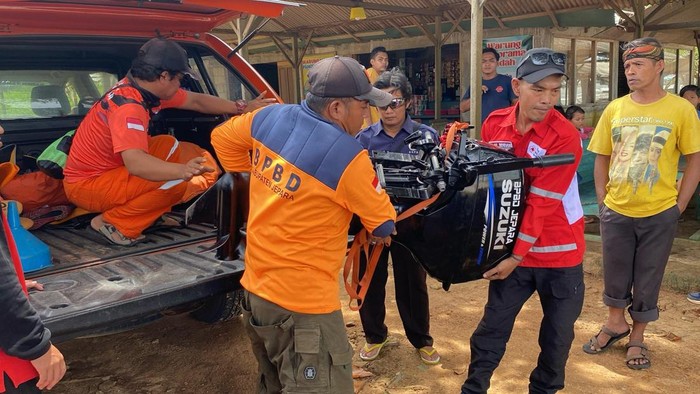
[7,201,52,272]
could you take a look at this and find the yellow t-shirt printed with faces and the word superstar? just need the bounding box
[588,94,700,217]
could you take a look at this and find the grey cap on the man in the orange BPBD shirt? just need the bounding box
[309,55,394,107]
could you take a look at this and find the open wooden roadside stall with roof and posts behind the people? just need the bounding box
[213,0,700,132]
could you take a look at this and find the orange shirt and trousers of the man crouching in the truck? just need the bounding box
[63,78,204,238]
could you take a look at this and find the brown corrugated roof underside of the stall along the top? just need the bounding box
[214,0,700,52]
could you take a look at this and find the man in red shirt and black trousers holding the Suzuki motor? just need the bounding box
[462,48,585,393]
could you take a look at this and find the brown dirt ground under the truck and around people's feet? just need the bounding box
[52,220,700,394]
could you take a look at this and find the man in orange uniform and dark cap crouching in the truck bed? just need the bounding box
[63,38,274,246]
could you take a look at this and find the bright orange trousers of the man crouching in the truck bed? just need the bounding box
[63,135,187,238]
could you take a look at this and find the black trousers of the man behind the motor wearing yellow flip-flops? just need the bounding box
[360,243,433,349]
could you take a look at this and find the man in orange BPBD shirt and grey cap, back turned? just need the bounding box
[212,56,396,394]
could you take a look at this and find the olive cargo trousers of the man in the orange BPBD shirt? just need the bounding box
[243,291,354,394]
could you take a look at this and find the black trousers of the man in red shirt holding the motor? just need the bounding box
[462,264,585,394]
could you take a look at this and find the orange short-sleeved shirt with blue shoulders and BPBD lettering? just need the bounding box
[212,103,396,314]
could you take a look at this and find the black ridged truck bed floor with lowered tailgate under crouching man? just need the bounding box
[27,219,244,341]
